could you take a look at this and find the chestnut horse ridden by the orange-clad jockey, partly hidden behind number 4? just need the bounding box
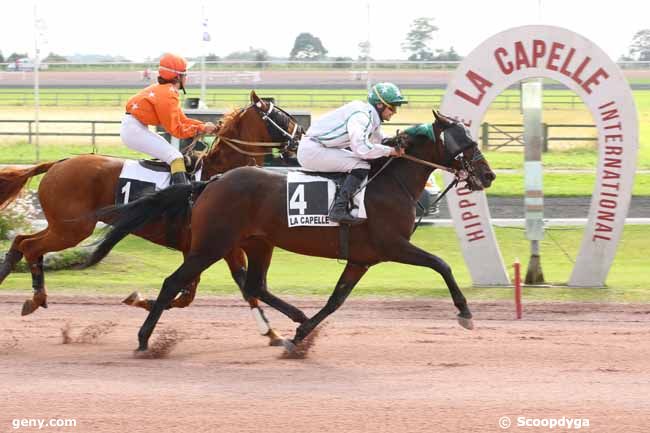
[0,92,303,340]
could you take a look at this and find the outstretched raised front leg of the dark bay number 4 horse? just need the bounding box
[386,239,474,329]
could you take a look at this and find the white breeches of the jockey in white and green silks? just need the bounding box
[298,136,370,173]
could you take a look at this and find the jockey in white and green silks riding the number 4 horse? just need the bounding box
[298,83,407,224]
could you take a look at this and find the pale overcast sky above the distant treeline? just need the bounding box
[0,0,650,60]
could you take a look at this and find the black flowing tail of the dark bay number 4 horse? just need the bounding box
[83,182,197,268]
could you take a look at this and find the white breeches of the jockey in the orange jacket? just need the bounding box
[120,114,183,164]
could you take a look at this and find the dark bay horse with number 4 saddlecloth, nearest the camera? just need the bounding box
[89,112,495,351]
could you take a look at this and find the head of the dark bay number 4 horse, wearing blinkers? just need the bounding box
[432,110,496,191]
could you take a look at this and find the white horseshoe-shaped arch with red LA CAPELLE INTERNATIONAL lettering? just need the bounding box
[441,25,639,287]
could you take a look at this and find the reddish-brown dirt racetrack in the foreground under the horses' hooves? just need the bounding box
[0,293,650,433]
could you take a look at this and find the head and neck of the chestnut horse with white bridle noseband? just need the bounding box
[204,91,304,176]
